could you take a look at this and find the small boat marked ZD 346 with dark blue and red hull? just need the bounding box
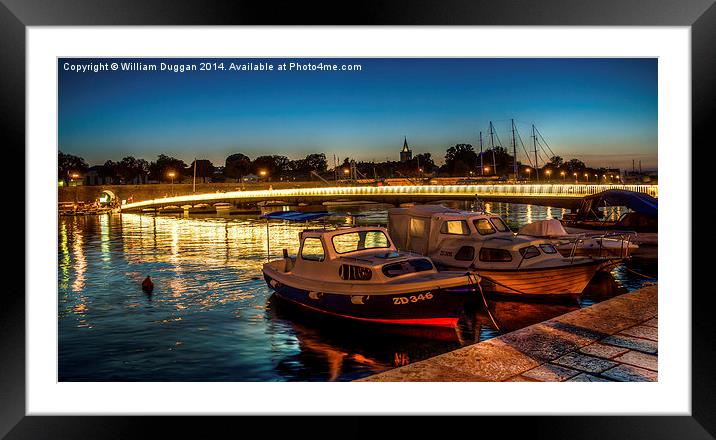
[263,217,478,327]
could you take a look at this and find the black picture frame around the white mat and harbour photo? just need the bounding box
[0,0,716,439]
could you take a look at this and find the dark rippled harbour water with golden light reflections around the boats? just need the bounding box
[58,203,657,381]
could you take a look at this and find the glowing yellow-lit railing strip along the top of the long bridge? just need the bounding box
[122,184,659,210]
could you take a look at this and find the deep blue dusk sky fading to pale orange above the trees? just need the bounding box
[58,58,658,169]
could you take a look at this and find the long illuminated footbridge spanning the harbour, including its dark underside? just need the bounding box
[122,184,658,212]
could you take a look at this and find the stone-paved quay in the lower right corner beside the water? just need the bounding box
[357,285,658,382]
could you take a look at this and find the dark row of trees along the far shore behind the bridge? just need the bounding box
[58,144,605,184]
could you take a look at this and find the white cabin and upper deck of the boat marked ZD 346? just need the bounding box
[278,226,437,284]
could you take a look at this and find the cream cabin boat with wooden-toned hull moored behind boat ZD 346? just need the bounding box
[388,205,612,297]
